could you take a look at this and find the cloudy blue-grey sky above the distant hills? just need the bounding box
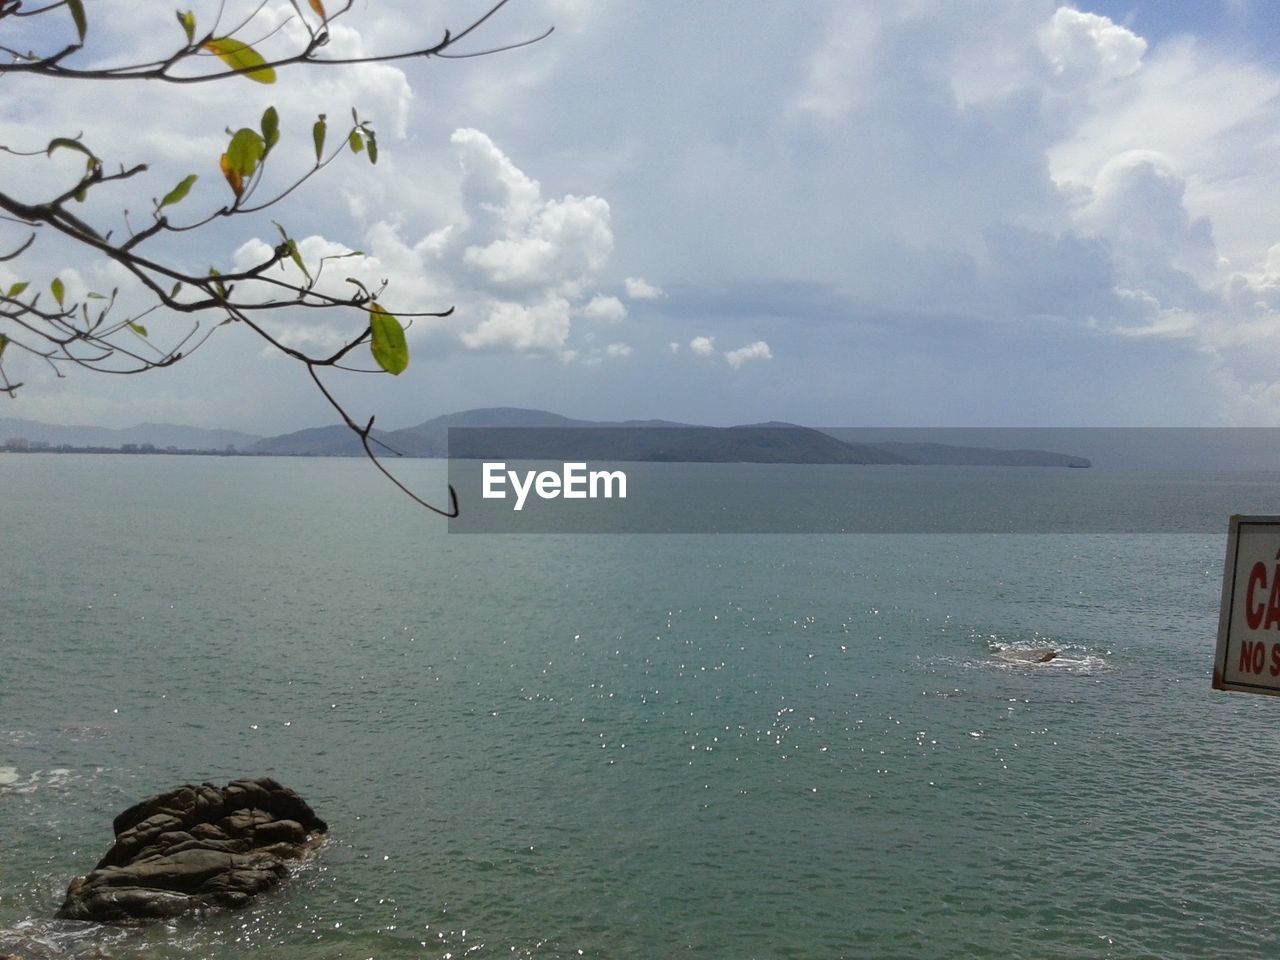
[0,0,1280,434]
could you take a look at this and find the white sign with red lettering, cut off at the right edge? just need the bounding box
[1213,516,1280,696]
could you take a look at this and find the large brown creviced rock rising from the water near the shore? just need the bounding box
[58,777,329,923]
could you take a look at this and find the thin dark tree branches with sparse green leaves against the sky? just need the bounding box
[0,0,550,517]
